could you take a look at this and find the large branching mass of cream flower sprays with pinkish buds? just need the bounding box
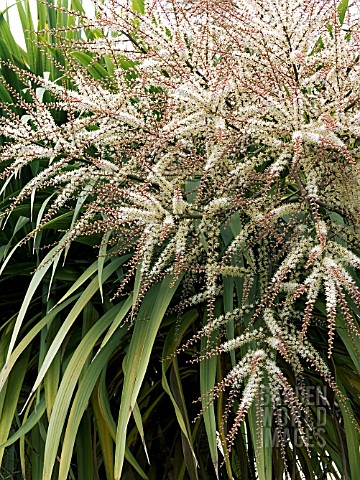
[0,0,360,475]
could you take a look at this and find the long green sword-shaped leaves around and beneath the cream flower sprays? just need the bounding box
[0,0,360,480]
